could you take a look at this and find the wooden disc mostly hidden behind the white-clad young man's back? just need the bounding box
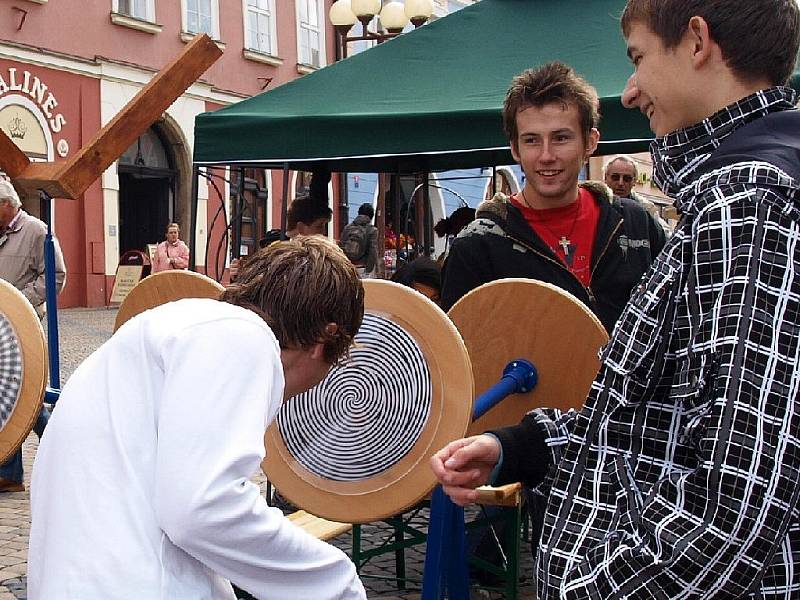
[114,270,225,331]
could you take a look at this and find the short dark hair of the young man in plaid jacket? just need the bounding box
[621,0,800,85]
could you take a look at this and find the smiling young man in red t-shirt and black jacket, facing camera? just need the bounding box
[442,63,664,333]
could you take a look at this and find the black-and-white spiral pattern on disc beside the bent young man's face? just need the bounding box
[278,313,432,481]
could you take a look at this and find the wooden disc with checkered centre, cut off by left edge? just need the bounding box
[0,279,47,462]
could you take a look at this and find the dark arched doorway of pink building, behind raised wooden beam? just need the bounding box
[117,126,177,255]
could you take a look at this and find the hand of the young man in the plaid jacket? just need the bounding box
[431,435,500,506]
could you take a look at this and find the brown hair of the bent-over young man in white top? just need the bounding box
[220,236,364,364]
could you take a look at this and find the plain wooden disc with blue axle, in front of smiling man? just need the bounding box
[448,279,608,435]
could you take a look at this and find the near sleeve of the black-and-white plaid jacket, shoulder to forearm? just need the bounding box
[560,185,800,599]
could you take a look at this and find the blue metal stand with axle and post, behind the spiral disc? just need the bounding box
[422,359,538,600]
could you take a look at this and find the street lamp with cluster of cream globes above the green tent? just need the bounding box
[328,0,433,58]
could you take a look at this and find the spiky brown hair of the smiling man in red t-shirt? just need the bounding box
[503,62,600,147]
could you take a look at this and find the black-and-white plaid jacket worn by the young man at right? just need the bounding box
[494,88,800,599]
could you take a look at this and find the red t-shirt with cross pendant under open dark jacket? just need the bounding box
[511,188,600,287]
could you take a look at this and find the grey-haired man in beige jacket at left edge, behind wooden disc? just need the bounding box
[0,180,67,492]
